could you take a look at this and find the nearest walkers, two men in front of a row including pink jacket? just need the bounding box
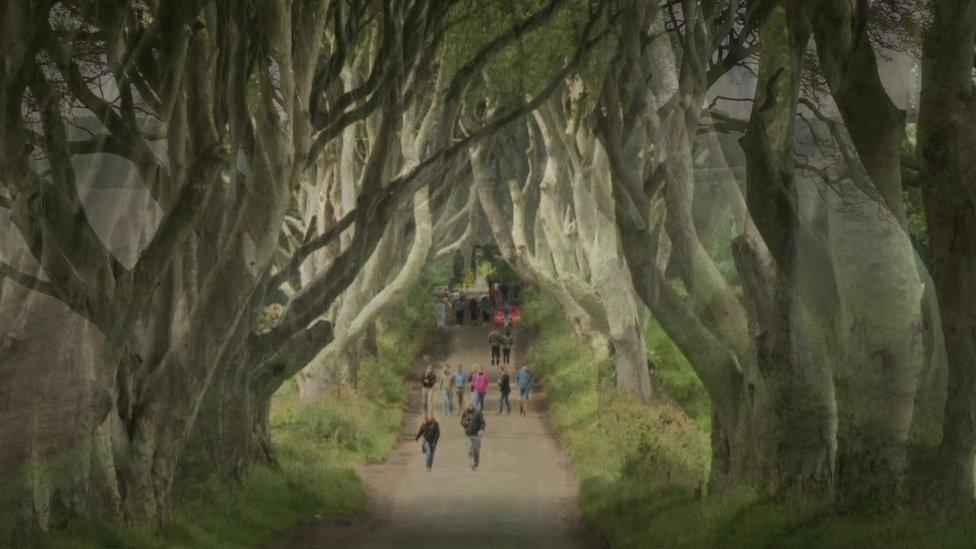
[415,362,533,471]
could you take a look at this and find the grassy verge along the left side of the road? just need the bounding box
[32,287,430,549]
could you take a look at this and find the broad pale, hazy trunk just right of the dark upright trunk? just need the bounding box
[829,191,925,505]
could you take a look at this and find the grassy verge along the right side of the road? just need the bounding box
[525,297,976,548]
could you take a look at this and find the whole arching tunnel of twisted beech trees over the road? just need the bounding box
[0,0,976,531]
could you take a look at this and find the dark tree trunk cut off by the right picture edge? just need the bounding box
[918,0,976,508]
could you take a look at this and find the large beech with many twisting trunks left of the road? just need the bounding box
[0,0,599,529]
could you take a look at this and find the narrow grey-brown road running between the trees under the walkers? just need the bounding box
[288,326,599,548]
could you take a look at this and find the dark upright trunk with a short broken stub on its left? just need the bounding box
[732,9,835,493]
